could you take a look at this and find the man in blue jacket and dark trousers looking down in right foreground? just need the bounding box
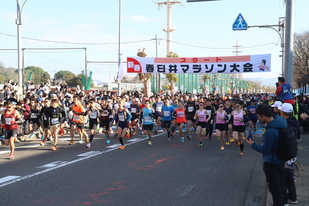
[247,105,287,206]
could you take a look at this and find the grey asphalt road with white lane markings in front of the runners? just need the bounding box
[0,129,266,206]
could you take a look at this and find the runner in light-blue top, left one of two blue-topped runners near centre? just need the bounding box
[141,100,154,146]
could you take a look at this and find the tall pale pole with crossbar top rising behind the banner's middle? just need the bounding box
[155,0,182,55]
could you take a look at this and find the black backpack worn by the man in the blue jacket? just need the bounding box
[275,119,299,161]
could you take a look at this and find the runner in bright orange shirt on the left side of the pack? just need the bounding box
[69,95,88,145]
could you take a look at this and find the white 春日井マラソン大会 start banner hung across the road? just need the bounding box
[127,54,271,74]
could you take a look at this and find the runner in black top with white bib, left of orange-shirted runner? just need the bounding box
[45,99,65,151]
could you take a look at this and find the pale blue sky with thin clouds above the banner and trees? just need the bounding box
[0,0,309,82]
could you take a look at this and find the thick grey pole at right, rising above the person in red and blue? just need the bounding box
[283,0,294,85]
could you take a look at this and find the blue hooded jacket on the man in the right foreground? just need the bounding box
[251,116,287,164]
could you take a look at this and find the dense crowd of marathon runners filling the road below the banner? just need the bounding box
[0,79,308,159]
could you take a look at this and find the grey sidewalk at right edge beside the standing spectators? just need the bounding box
[266,134,309,206]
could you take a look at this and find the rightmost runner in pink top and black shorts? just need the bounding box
[232,101,247,156]
